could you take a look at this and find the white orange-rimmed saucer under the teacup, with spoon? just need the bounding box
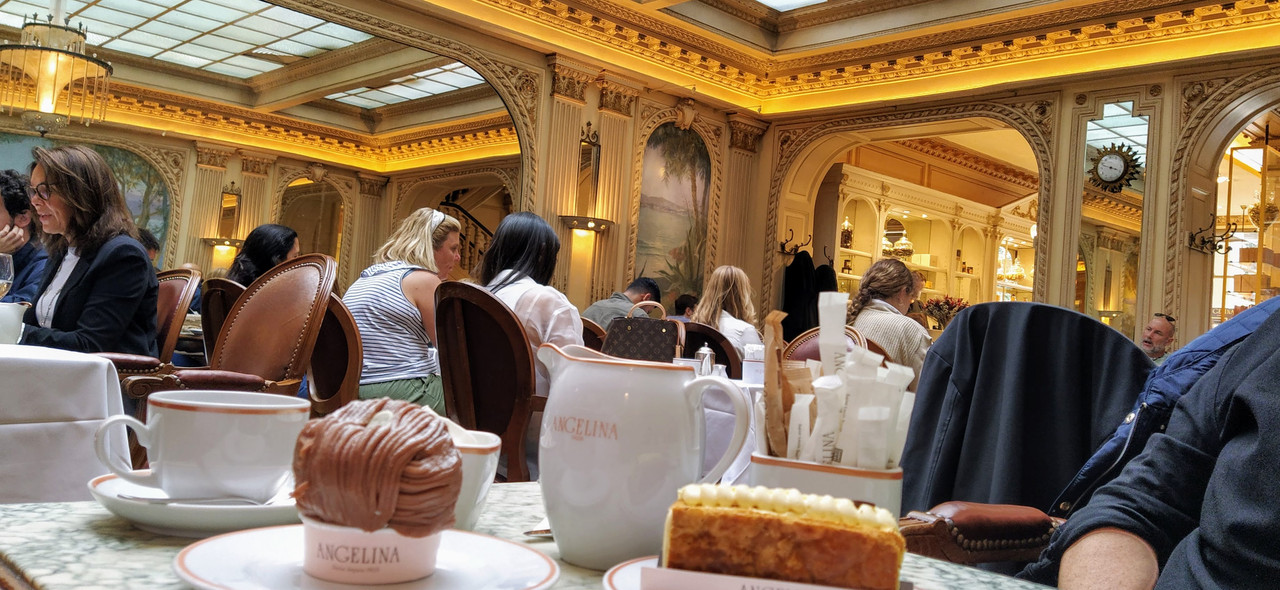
[88,474,300,538]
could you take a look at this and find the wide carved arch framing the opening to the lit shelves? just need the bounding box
[756,95,1059,308]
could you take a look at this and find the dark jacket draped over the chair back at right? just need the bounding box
[901,302,1152,514]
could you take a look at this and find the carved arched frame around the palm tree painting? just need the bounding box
[623,99,727,289]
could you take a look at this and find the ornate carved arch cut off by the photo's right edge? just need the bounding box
[1162,64,1280,333]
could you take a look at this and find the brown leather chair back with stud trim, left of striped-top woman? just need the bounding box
[209,253,337,381]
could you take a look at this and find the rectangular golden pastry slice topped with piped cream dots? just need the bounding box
[662,484,906,590]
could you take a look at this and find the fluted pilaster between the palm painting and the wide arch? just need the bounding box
[717,114,769,266]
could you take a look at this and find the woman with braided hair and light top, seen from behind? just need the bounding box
[845,259,931,392]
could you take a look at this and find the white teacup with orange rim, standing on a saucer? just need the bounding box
[93,390,311,502]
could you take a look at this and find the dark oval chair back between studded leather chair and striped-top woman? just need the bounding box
[307,293,365,417]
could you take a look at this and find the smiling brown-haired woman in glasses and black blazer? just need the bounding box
[20,146,160,357]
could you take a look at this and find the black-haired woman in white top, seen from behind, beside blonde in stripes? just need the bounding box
[480,212,582,396]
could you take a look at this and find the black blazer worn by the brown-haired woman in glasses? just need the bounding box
[22,235,160,357]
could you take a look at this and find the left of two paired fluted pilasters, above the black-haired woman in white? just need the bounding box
[538,55,595,291]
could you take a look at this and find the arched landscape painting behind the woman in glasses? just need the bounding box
[0,133,170,265]
